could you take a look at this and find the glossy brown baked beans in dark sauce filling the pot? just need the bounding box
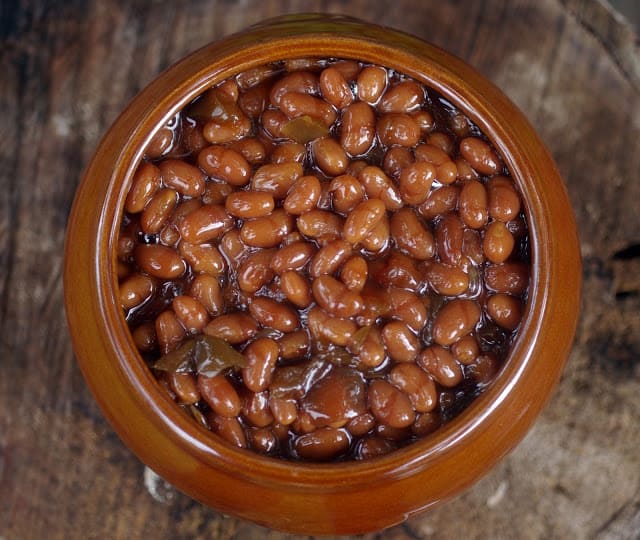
[117,58,530,461]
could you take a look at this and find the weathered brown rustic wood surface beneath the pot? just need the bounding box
[0,0,640,540]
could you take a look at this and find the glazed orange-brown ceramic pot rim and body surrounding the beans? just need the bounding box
[64,15,581,534]
